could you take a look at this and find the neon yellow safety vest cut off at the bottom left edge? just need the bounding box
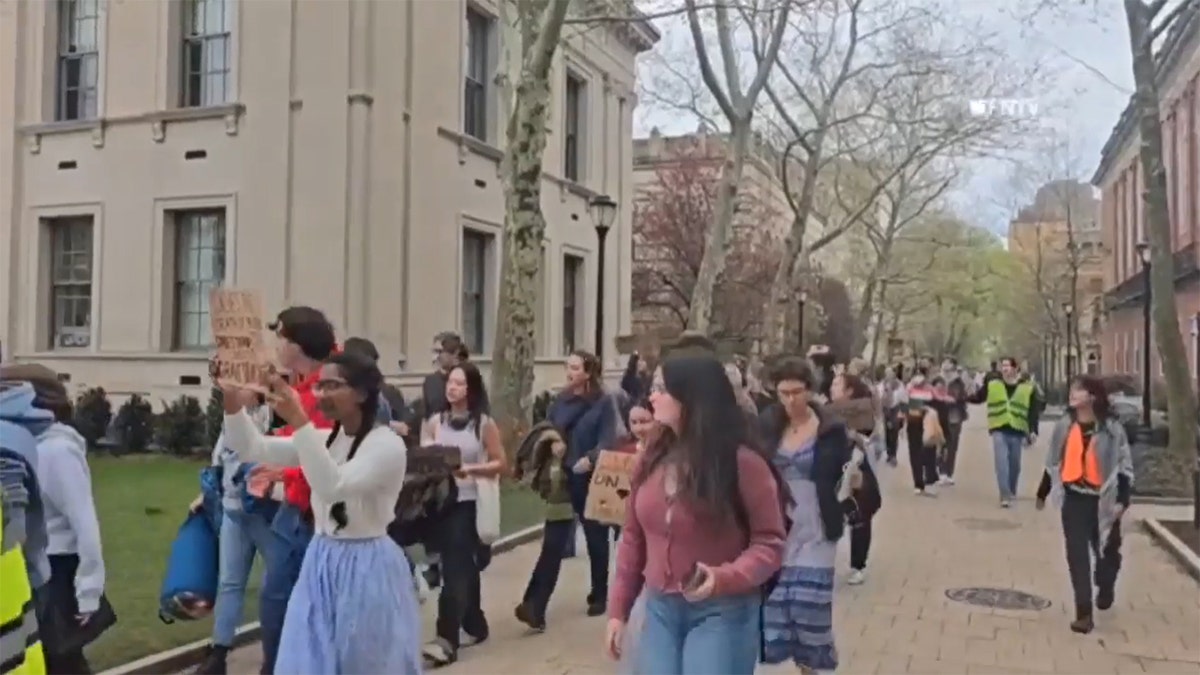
[0,494,46,675]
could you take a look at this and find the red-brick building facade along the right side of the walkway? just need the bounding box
[1092,14,1200,380]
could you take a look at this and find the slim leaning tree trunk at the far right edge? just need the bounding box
[1124,0,1196,461]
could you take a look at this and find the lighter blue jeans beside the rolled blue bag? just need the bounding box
[212,510,271,647]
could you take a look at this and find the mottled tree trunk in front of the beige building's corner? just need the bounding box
[491,0,570,453]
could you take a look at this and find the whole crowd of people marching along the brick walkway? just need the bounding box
[0,306,1132,675]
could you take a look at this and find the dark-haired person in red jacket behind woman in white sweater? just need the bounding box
[258,306,336,675]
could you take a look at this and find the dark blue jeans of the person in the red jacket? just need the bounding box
[258,504,312,673]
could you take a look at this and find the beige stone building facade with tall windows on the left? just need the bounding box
[0,0,658,398]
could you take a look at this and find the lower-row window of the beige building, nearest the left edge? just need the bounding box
[49,216,92,348]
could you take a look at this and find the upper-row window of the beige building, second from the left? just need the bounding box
[180,0,233,108]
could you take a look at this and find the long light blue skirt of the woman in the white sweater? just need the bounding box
[275,534,421,675]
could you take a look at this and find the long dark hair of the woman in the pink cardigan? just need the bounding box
[634,354,749,520]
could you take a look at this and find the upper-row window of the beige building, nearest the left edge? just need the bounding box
[55,0,100,120]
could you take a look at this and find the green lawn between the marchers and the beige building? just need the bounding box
[88,455,542,671]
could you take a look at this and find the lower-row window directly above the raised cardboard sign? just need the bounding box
[174,209,226,350]
